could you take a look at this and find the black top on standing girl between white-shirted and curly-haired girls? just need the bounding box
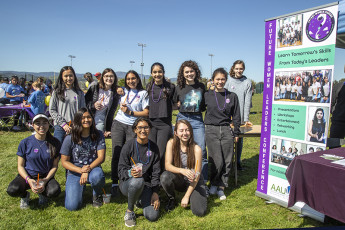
[146,82,175,121]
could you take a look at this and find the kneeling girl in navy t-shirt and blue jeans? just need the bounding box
[60,108,106,211]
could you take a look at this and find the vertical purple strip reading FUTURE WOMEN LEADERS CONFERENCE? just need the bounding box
[257,20,276,194]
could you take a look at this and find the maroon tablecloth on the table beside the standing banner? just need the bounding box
[286,148,345,223]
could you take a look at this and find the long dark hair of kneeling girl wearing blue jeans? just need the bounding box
[72,107,99,145]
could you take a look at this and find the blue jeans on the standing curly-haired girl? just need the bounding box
[176,113,208,181]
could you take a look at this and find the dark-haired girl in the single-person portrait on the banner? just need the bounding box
[308,108,328,143]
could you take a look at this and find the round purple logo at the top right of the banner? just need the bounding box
[306,10,334,42]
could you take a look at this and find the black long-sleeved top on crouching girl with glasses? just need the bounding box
[118,138,161,192]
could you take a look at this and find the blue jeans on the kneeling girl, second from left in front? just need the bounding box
[65,167,105,211]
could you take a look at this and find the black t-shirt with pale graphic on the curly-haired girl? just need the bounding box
[174,82,205,113]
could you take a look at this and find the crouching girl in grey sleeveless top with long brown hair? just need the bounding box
[161,120,207,216]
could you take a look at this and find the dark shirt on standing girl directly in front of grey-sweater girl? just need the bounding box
[204,89,241,134]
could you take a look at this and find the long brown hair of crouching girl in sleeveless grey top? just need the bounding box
[172,120,195,169]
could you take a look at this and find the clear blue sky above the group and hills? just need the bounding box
[0,0,345,82]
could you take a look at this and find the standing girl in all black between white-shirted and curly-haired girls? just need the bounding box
[146,62,175,168]
